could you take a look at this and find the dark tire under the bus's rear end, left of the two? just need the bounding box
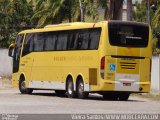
[103,92,118,101]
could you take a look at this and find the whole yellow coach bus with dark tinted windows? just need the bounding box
[9,21,152,100]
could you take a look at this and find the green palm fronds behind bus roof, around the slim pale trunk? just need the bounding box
[32,0,97,27]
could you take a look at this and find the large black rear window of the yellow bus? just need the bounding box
[108,21,149,47]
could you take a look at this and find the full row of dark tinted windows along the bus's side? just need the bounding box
[22,28,101,56]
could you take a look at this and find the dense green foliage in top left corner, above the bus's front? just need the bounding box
[0,0,34,47]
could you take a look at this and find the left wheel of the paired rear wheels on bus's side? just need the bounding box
[66,77,75,98]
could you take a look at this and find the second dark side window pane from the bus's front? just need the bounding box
[34,33,45,52]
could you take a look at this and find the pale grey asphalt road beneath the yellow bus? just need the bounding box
[0,88,160,114]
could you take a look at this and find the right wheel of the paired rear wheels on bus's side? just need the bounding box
[77,78,89,99]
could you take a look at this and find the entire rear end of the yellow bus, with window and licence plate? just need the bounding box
[101,21,152,100]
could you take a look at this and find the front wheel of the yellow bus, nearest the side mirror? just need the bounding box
[19,77,33,94]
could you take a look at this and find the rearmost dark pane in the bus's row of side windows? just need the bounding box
[89,28,101,50]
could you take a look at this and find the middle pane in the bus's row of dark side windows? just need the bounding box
[56,31,68,50]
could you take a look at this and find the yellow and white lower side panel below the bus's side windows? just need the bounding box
[28,50,98,91]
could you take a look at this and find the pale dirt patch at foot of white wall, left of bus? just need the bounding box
[0,77,12,89]
